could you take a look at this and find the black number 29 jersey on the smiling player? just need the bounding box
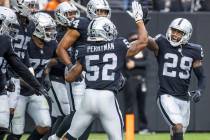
[156,35,203,100]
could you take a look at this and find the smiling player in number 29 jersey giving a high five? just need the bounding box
[148,18,205,140]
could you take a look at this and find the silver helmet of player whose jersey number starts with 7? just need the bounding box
[33,12,57,42]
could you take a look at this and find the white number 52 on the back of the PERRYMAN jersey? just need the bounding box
[85,53,117,81]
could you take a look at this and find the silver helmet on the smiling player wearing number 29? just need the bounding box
[166,18,193,47]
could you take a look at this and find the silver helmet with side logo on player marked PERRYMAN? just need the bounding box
[87,17,118,41]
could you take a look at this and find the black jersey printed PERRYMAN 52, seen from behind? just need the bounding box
[76,38,128,91]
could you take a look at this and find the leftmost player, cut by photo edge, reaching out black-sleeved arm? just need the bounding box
[0,7,46,140]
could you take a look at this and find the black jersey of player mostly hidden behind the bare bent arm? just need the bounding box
[50,25,67,79]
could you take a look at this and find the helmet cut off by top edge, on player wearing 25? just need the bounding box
[11,0,39,17]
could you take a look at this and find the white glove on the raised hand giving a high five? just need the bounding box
[132,0,143,22]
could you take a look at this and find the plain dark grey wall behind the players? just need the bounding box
[22,11,210,132]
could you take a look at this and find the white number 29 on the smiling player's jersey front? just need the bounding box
[163,53,193,79]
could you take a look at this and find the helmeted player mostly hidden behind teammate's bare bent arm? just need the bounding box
[46,2,79,137]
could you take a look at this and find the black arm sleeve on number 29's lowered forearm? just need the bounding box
[193,66,206,91]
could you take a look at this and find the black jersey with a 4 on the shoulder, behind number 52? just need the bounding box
[68,17,90,63]
